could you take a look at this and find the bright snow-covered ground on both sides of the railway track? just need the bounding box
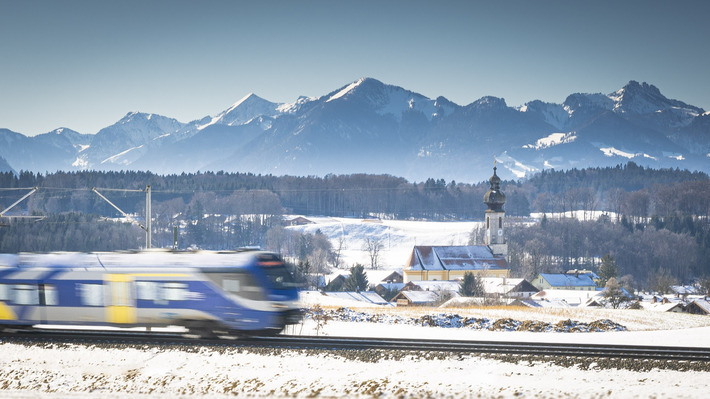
[0,295,710,399]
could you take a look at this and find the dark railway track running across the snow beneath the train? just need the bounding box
[0,329,710,362]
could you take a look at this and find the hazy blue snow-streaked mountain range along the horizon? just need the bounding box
[0,78,710,182]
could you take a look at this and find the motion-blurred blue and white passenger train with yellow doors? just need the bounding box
[0,250,302,337]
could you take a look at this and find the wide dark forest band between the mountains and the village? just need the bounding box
[0,162,710,287]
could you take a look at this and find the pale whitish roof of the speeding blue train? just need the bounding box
[0,249,278,269]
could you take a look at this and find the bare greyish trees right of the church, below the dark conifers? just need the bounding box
[508,216,710,289]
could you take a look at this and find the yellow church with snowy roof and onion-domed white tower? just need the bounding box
[403,166,510,283]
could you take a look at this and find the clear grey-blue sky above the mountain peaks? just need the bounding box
[0,0,710,135]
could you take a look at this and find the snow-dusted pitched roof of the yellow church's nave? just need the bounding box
[407,245,508,270]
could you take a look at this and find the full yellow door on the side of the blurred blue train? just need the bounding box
[104,274,137,324]
